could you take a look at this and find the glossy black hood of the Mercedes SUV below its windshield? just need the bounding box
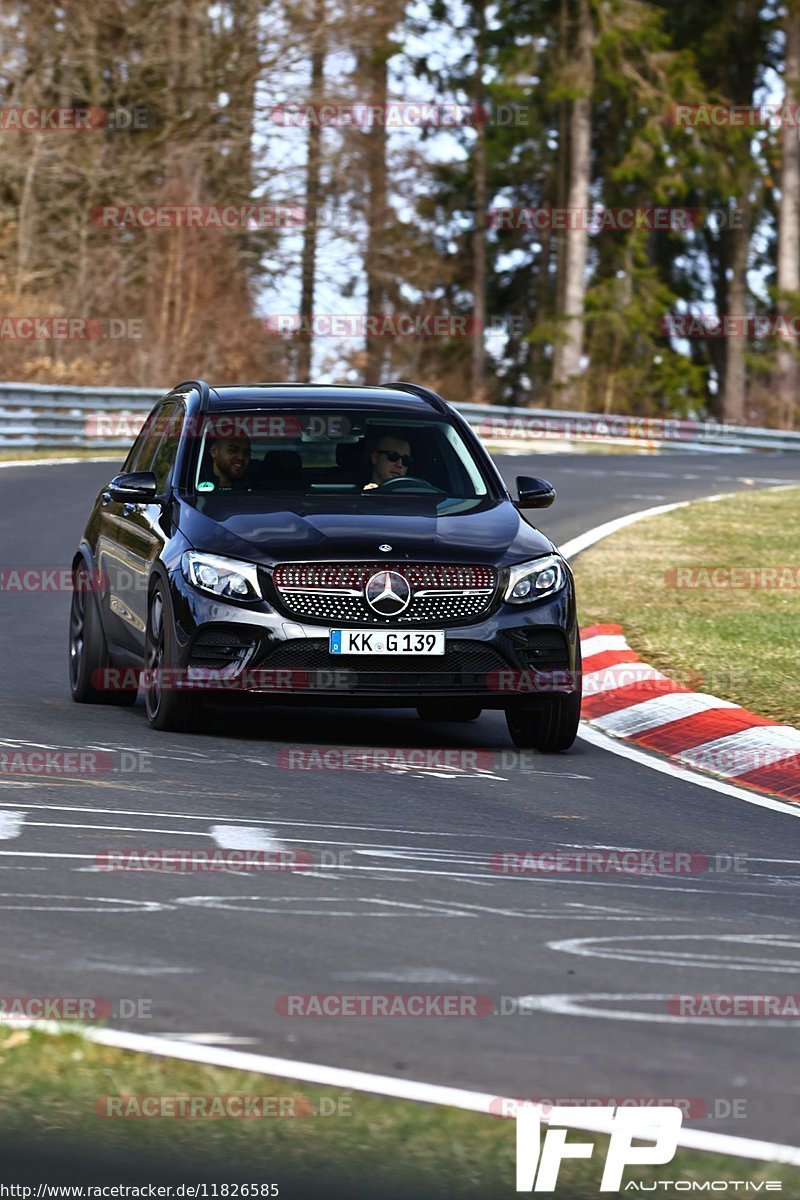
[181,500,554,566]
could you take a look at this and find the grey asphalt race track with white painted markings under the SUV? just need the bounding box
[0,452,800,1145]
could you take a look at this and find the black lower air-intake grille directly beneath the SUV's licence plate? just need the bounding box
[258,638,509,694]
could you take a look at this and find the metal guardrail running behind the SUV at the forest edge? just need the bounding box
[0,383,800,451]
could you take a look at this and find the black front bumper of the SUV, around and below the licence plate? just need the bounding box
[170,571,581,708]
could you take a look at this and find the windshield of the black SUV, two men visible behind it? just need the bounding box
[193,408,488,511]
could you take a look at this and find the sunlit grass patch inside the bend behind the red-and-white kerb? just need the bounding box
[575,487,800,725]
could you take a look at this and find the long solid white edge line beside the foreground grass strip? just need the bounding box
[2,1019,800,1165]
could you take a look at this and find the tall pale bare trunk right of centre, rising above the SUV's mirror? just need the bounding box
[553,0,594,408]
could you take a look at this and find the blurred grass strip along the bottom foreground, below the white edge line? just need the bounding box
[0,1027,800,1200]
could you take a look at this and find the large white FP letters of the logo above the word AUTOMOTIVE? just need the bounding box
[517,1104,682,1192]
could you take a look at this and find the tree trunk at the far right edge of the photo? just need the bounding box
[776,0,800,430]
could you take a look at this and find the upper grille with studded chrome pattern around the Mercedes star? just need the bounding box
[272,563,497,625]
